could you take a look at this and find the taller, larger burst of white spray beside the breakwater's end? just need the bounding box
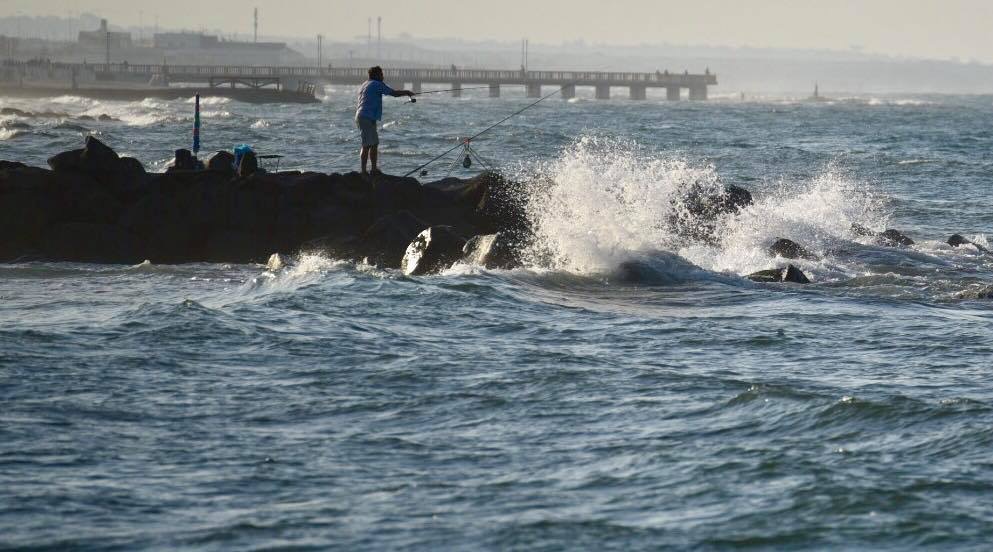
[526,136,722,274]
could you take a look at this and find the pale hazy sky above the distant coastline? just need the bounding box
[0,0,993,62]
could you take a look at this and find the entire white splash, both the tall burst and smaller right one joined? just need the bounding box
[526,136,886,275]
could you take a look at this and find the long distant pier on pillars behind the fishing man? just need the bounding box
[50,63,717,101]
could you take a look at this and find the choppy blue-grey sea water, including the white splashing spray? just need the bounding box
[0,89,993,550]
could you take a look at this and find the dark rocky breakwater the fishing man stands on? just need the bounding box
[0,137,527,269]
